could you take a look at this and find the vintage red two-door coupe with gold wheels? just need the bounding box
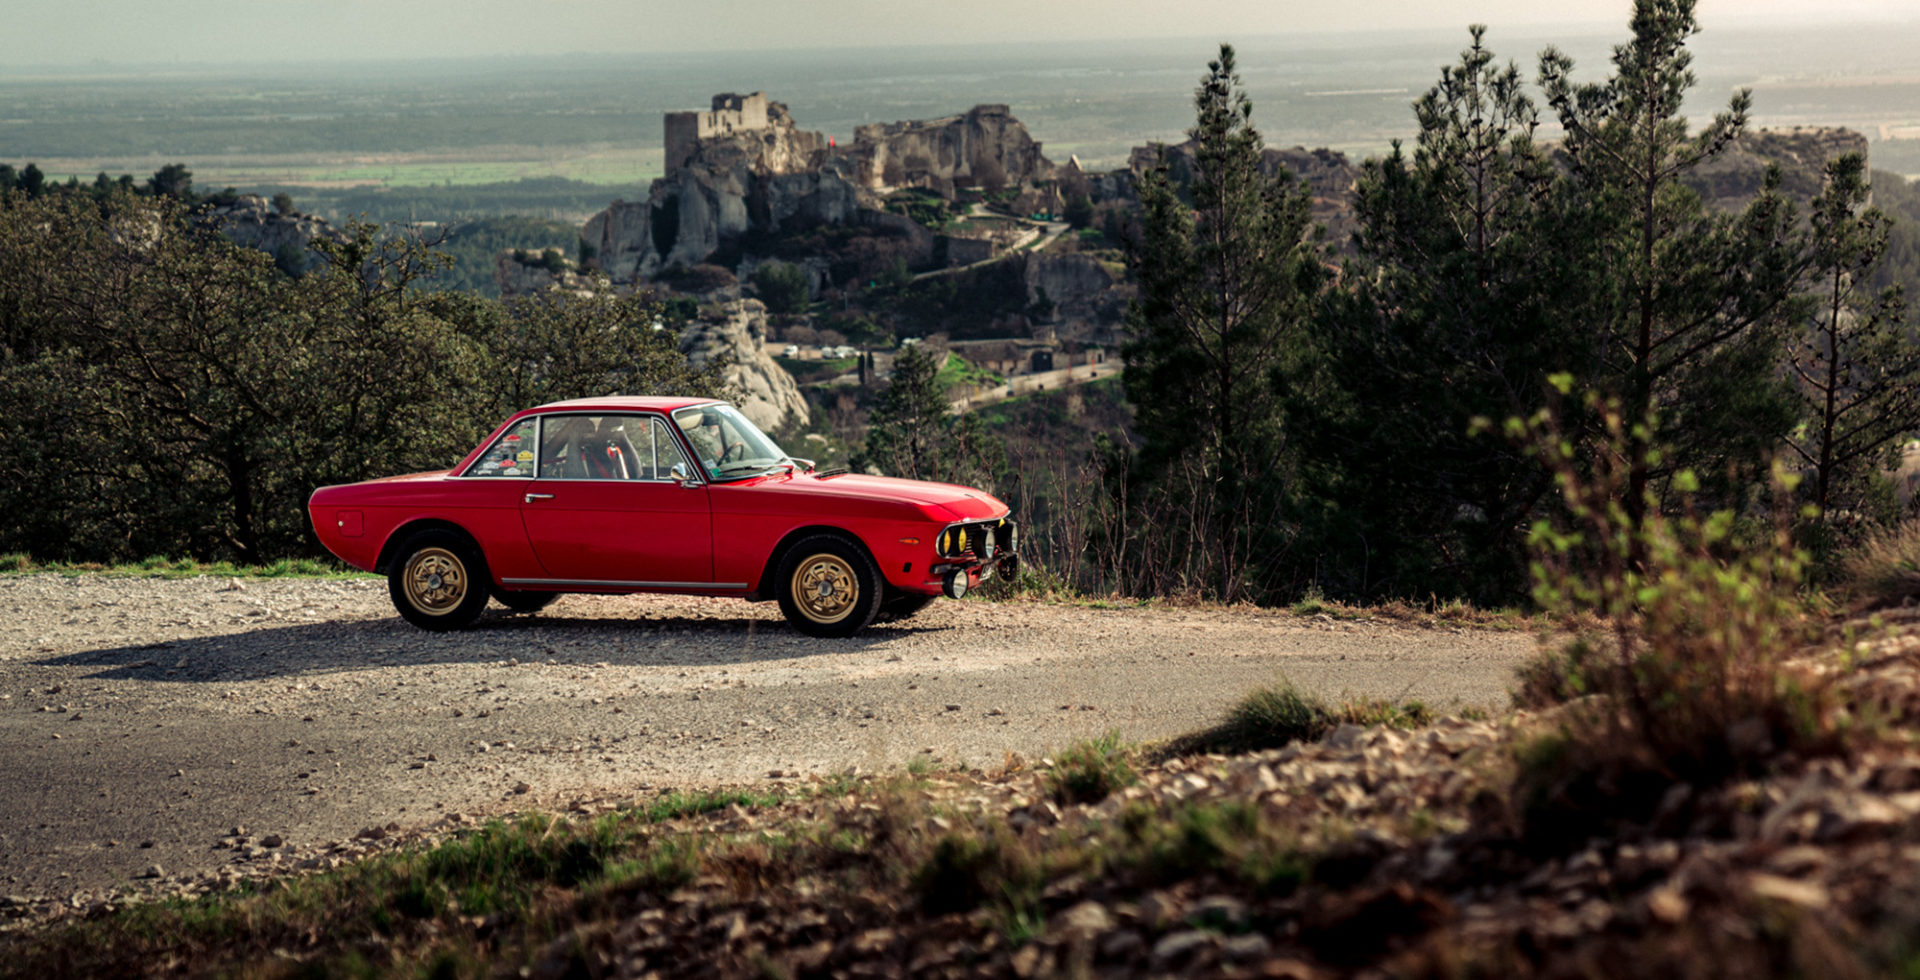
[307,398,1018,636]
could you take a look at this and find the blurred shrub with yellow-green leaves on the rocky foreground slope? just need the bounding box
[1509,390,1837,844]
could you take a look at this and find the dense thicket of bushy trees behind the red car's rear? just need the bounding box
[0,194,720,561]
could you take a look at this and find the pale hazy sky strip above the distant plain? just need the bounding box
[0,0,1920,67]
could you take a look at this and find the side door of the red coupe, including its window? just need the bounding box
[520,415,721,588]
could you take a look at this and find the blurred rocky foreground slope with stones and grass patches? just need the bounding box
[8,599,1920,978]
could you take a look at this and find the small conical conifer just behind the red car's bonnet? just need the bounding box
[852,344,1006,490]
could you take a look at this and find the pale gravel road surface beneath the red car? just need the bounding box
[0,575,1534,894]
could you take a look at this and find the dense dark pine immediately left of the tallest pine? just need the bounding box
[1292,25,1594,601]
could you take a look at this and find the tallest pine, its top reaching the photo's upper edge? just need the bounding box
[1540,0,1805,527]
